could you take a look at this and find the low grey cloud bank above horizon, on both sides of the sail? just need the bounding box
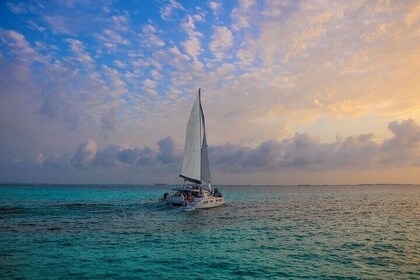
[36,120,420,173]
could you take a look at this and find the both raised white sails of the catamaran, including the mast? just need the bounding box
[179,89,211,185]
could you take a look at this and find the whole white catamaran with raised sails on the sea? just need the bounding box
[161,89,225,209]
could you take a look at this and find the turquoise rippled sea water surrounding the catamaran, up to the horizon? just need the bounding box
[0,185,420,279]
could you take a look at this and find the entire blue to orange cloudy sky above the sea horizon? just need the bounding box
[0,0,420,185]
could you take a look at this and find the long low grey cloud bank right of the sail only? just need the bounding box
[209,120,420,172]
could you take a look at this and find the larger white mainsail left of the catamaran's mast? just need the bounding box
[180,92,202,184]
